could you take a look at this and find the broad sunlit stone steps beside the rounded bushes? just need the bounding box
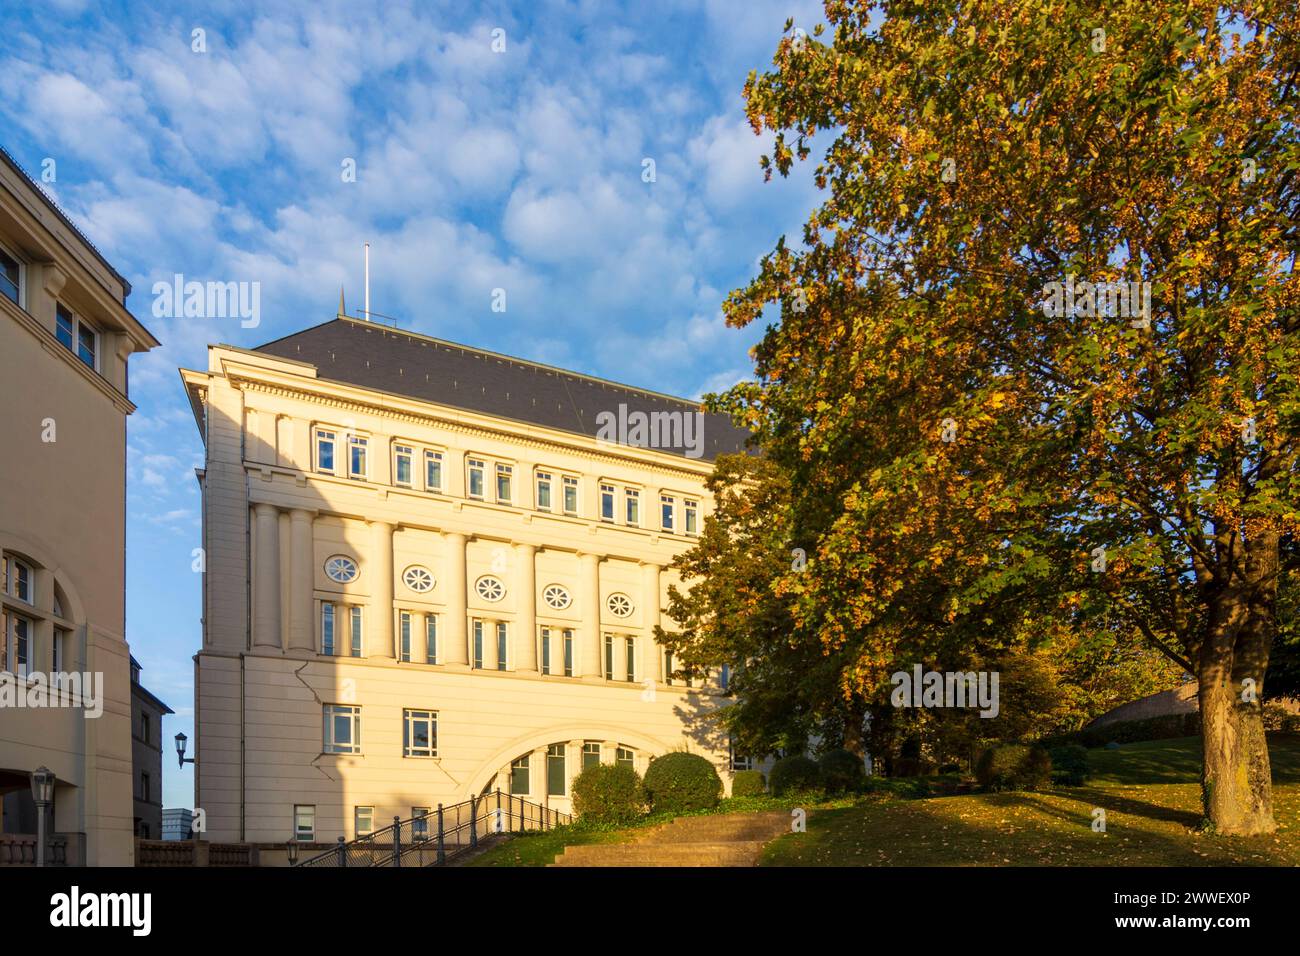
[551,810,790,866]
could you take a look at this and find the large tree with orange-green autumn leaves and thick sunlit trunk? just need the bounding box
[720,0,1300,834]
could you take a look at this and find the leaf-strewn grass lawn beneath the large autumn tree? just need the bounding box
[762,735,1300,866]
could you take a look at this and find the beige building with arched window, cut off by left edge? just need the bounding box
[0,143,159,865]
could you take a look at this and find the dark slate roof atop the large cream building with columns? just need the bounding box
[256,316,749,460]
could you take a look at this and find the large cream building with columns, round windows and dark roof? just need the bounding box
[182,316,744,844]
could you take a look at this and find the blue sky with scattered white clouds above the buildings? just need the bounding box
[0,0,820,806]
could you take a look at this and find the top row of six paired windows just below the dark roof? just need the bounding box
[313,428,699,535]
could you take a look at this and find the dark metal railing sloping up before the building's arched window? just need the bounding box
[296,790,573,866]
